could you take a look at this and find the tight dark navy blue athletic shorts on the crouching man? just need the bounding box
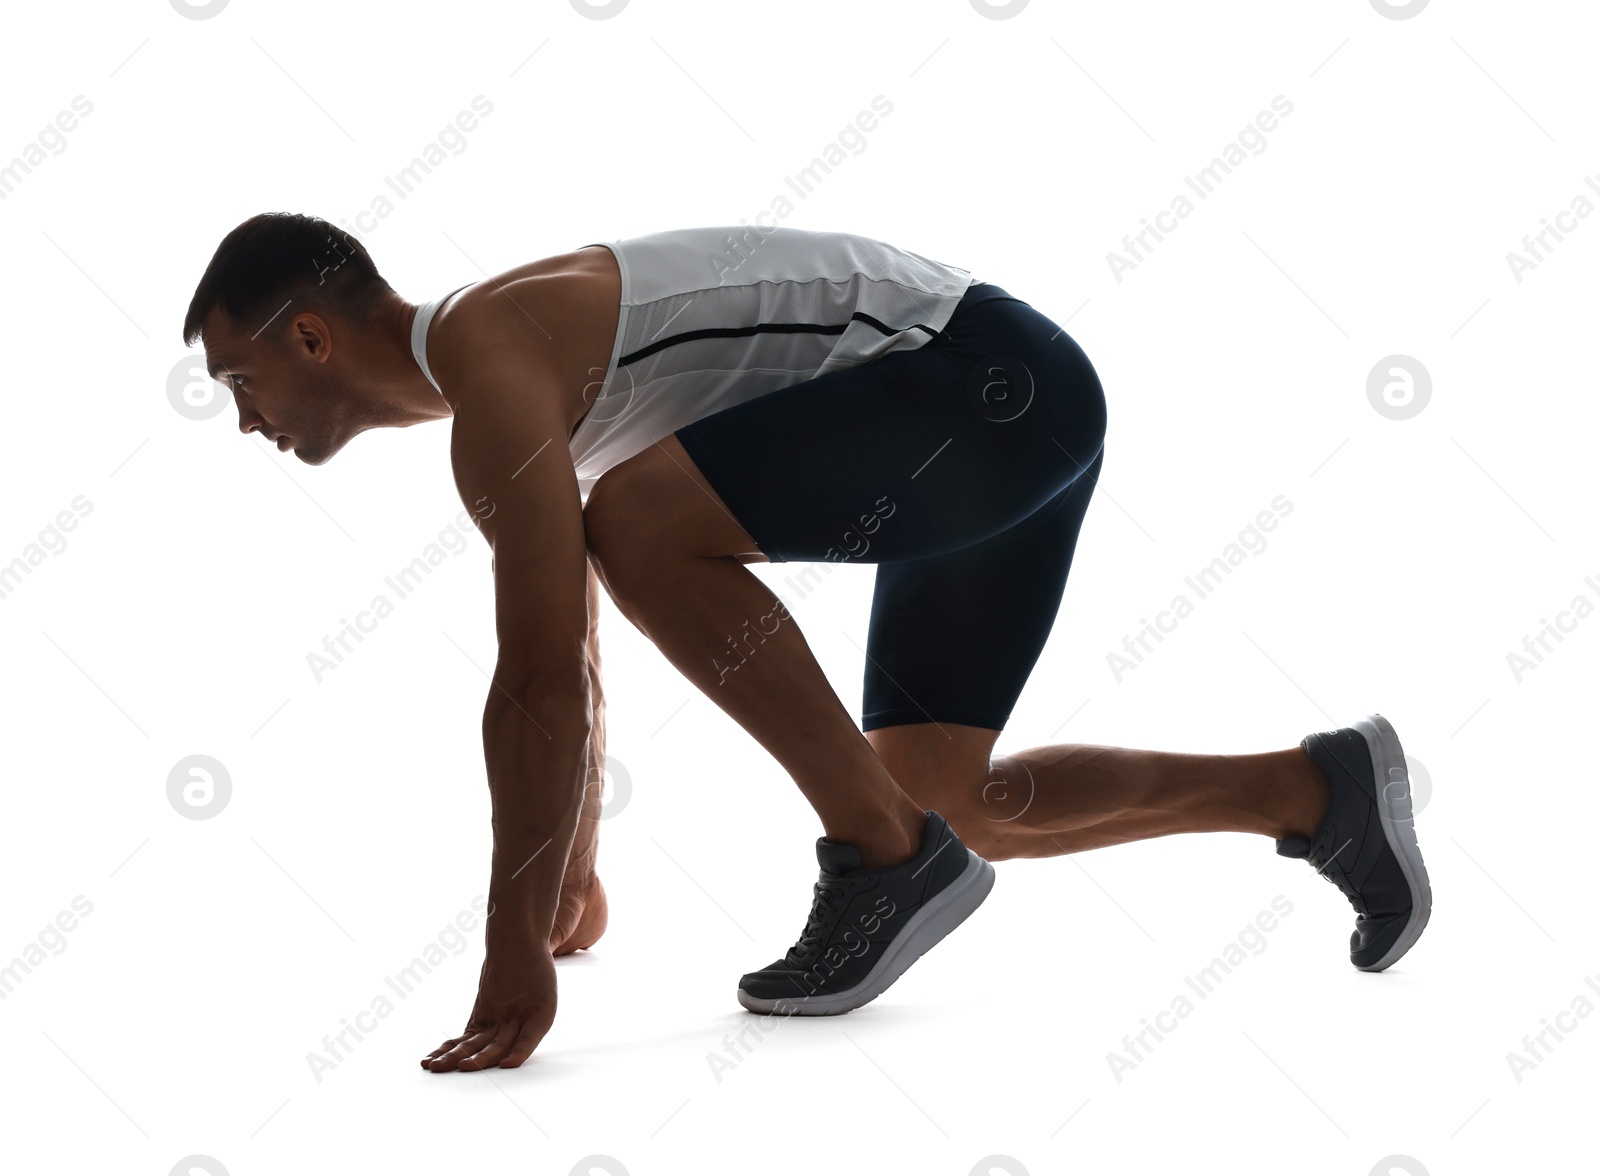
[675,283,1106,731]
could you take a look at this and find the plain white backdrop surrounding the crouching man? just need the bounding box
[0,0,1600,1176]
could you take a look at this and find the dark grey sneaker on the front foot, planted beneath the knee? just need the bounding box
[739,810,995,1016]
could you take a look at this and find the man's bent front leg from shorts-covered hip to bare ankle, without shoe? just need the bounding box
[584,288,1106,866]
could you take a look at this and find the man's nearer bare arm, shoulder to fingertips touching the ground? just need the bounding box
[422,315,594,1070]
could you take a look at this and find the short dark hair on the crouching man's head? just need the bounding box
[184,213,392,347]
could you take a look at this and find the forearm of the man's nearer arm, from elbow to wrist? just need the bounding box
[483,685,590,944]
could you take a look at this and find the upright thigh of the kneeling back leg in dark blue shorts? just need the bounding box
[861,450,1104,731]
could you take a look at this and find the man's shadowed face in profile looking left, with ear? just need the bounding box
[202,309,368,466]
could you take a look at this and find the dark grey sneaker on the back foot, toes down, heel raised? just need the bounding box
[1277,715,1434,971]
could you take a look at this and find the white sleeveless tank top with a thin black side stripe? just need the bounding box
[411,226,978,501]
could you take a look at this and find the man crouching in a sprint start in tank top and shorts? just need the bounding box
[184,214,1430,1070]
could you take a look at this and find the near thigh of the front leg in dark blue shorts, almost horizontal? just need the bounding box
[675,291,1106,563]
